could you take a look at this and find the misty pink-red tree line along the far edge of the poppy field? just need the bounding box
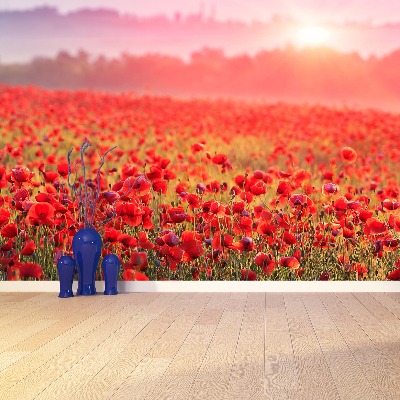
[0,47,400,111]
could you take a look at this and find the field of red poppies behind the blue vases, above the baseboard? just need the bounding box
[0,86,400,280]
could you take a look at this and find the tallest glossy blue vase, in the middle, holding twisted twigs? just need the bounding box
[72,228,103,296]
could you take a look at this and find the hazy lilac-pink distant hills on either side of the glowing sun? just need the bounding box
[0,7,400,63]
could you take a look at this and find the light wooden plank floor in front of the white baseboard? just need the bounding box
[0,293,400,400]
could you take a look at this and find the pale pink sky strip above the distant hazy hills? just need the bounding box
[0,0,400,24]
